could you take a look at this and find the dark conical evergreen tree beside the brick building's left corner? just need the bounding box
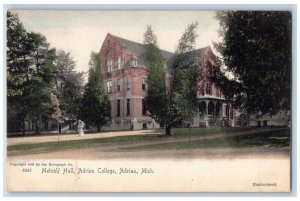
[79,52,111,132]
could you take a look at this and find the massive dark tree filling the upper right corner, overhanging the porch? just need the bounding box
[215,11,291,115]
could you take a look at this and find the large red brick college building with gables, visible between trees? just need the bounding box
[100,33,233,130]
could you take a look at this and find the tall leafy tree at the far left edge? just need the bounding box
[7,11,32,134]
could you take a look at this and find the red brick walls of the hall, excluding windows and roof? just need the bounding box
[100,34,224,124]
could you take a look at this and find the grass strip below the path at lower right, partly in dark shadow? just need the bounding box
[124,130,290,150]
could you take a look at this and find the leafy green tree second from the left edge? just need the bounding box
[26,33,56,134]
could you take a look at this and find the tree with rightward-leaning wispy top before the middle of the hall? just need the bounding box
[166,23,199,136]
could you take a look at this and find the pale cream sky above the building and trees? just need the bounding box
[14,10,221,74]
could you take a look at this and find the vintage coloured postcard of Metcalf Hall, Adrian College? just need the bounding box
[5,9,293,192]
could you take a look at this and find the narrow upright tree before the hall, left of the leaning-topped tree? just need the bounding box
[144,26,167,125]
